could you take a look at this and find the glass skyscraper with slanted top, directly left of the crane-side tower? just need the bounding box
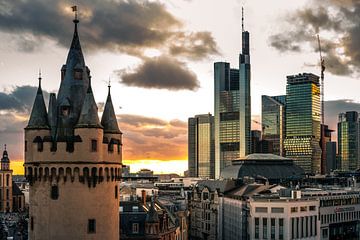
[261,95,286,156]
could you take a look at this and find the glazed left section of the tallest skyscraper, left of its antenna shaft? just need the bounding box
[214,62,240,178]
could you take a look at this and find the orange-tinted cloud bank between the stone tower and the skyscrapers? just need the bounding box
[118,114,187,160]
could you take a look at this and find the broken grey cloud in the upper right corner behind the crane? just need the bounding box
[269,0,360,75]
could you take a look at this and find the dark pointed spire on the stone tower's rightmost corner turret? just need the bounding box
[101,81,121,133]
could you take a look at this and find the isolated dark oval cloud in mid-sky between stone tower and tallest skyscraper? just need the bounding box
[117,56,199,90]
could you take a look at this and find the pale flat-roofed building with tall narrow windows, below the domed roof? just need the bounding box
[248,195,320,240]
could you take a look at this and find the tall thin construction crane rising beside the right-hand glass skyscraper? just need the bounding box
[317,34,326,174]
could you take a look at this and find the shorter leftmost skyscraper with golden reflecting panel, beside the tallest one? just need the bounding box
[188,113,215,179]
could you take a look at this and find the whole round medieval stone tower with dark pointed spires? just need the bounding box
[24,15,122,240]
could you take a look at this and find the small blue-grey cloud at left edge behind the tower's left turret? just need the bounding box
[0,85,49,113]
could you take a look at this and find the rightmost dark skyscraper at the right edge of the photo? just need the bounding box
[338,111,360,171]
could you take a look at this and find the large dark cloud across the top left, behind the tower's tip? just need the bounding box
[0,0,217,59]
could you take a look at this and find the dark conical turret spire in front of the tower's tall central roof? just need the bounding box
[75,76,102,128]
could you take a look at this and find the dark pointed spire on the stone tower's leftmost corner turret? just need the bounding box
[26,72,49,129]
